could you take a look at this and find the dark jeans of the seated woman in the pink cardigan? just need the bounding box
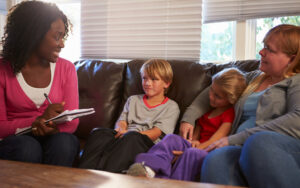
[0,133,79,166]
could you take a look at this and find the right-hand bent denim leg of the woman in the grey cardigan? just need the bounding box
[240,132,300,188]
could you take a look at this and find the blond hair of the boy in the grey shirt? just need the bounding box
[140,59,173,84]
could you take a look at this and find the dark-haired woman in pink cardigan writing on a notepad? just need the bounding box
[0,1,79,166]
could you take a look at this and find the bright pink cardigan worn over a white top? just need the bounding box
[0,58,79,139]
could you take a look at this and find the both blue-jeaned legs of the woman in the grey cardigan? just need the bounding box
[201,131,300,188]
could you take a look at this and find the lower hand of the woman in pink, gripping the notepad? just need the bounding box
[31,116,59,136]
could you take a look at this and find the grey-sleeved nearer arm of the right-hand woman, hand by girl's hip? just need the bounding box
[228,75,300,145]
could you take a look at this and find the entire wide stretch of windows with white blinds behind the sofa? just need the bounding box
[0,0,300,62]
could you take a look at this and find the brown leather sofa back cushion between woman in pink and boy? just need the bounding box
[75,60,126,138]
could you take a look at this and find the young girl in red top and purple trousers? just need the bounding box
[127,68,246,181]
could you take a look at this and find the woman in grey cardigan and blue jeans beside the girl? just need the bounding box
[193,25,300,188]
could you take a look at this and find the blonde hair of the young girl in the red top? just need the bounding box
[212,68,247,104]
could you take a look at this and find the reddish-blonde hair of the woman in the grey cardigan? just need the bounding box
[243,24,300,95]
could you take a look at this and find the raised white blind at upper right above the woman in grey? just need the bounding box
[203,0,300,23]
